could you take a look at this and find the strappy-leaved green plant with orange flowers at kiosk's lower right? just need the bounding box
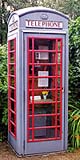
[69,104,80,148]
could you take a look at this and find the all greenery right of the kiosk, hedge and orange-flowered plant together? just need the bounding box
[69,17,80,148]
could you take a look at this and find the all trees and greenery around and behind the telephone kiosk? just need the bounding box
[0,0,80,148]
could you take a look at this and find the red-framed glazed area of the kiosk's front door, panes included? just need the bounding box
[27,37,62,142]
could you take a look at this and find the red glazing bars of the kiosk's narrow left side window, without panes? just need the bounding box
[8,38,16,139]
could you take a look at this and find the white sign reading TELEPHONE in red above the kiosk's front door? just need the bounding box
[26,20,63,29]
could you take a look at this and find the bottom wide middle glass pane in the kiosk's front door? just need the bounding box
[34,128,55,139]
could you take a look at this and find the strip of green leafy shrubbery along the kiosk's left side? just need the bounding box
[0,45,8,138]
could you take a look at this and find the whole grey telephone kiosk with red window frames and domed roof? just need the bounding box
[8,7,68,155]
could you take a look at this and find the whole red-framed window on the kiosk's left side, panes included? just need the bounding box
[8,39,16,138]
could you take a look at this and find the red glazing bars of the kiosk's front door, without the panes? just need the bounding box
[27,37,63,142]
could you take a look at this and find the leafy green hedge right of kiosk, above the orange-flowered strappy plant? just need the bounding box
[69,17,80,101]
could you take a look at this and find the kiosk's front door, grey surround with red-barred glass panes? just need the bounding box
[25,34,65,154]
